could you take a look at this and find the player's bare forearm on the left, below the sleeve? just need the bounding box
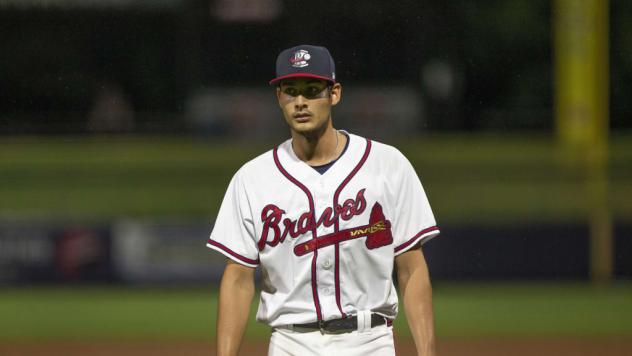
[216,259,255,356]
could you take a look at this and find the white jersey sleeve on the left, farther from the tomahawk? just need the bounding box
[206,171,259,267]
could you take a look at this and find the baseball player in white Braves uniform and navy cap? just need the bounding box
[207,45,439,356]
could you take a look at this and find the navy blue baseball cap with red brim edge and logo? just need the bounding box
[270,45,336,85]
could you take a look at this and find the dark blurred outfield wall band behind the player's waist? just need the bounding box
[0,220,632,285]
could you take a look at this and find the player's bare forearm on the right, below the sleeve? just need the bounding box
[395,244,436,356]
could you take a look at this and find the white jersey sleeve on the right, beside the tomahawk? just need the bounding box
[393,151,439,255]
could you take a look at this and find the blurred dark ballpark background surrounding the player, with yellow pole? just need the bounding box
[0,0,632,355]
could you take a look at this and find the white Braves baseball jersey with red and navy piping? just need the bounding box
[207,134,439,327]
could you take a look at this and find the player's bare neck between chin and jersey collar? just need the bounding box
[292,126,347,166]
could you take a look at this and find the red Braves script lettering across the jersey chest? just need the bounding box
[257,189,366,251]
